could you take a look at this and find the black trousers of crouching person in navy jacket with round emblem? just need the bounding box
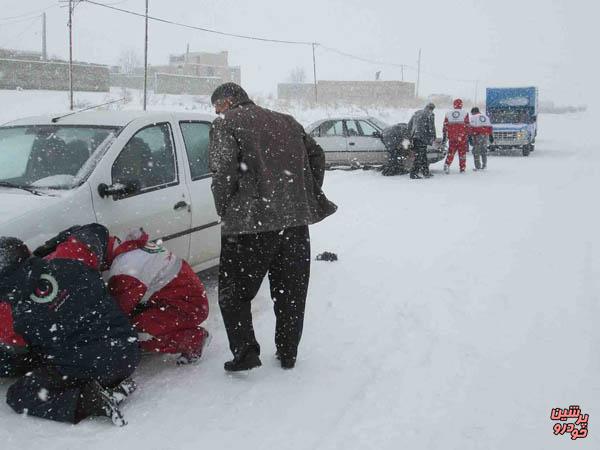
[0,350,135,423]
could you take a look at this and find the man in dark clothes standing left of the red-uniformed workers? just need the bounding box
[408,103,436,180]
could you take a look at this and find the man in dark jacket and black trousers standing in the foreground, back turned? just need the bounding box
[209,83,337,371]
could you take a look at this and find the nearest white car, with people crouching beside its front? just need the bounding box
[0,112,220,271]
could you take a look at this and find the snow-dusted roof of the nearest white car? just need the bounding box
[3,111,216,127]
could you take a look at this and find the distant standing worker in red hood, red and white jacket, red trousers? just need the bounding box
[443,98,469,173]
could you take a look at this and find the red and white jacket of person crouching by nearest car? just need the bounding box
[108,231,208,321]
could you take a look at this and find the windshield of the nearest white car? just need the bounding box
[0,125,119,189]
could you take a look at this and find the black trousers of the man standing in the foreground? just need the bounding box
[219,226,310,358]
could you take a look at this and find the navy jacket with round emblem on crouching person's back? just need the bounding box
[0,257,139,378]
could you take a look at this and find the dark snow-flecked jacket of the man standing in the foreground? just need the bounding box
[209,100,337,234]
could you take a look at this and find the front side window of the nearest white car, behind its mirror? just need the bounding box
[112,123,177,190]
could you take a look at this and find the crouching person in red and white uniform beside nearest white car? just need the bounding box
[108,229,209,364]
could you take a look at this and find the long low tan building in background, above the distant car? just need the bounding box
[277,81,415,107]
